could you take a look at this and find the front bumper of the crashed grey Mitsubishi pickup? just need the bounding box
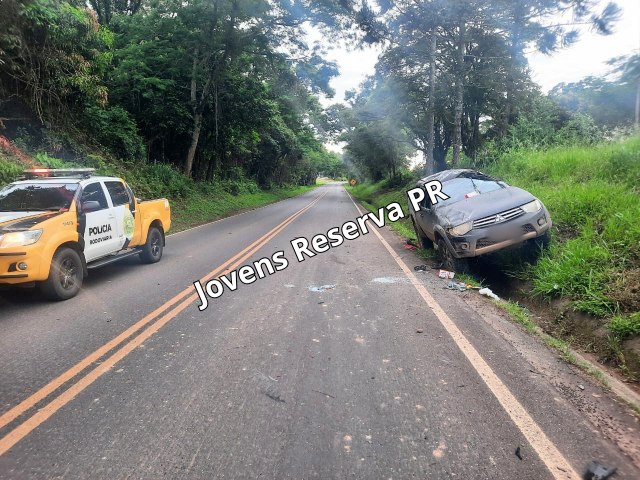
[445,207,552,258]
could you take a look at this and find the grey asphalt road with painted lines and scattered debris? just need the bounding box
[0,185,640,479]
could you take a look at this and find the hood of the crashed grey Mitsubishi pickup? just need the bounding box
[435,183,536,227]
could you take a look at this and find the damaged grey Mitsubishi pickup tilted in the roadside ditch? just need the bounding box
[409,169,551,272]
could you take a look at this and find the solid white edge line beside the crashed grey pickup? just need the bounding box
[345,188,582,480]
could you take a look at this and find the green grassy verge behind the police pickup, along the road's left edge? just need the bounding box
[0,153,315,231]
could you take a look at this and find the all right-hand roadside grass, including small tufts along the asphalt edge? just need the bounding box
[350,137,640,379]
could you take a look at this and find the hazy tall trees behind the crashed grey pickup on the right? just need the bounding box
[330,0,640,180]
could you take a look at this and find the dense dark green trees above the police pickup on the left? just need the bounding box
[0,0,344,186]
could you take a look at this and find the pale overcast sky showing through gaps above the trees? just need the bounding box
[310,0,640,105]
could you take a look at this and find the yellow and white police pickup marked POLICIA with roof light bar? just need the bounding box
[0,169,171,300]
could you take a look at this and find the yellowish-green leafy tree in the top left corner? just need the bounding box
[0,0,112,122]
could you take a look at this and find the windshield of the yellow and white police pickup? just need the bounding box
[0,183,78,212]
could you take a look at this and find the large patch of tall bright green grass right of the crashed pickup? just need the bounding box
[487,137,640,317]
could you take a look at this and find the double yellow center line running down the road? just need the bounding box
[0,191,326,455]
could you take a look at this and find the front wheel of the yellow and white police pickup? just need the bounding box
[40,248,84,301]
